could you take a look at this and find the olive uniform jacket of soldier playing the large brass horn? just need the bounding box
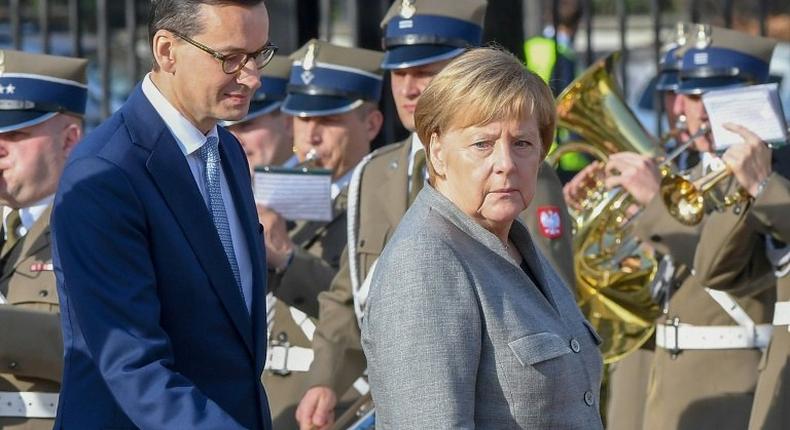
[635,176,775,430]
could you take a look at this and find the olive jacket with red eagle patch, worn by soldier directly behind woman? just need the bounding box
[310,138,575,393]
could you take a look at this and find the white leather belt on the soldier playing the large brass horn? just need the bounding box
[656,324,773,351]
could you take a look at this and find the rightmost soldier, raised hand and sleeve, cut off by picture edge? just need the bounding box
[694,131,790,430]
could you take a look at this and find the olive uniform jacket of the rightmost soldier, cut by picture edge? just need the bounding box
[694,174,790,430]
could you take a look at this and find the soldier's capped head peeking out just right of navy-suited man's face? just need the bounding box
[221,55,298,175]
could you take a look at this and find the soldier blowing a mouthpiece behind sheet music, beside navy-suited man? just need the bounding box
[259,40,383,429]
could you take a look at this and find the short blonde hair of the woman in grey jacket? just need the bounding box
[414,47,556,177]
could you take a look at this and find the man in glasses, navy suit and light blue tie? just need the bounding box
[52,0,276,429]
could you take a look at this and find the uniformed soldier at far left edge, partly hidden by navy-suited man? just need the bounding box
[0,50,88,430]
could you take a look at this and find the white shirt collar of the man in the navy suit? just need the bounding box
[142,73,218,155]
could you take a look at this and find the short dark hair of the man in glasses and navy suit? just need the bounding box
[148,0,263,69]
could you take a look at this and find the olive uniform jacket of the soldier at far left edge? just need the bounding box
[0,206,63,430]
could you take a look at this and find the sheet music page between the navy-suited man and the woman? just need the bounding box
[253,166,332,221]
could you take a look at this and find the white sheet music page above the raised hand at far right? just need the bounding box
[702,83,787,151]
